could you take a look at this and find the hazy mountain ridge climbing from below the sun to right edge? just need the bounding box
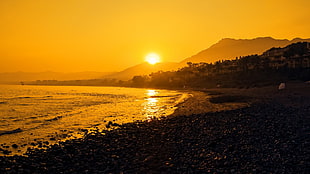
[107,37,310,80]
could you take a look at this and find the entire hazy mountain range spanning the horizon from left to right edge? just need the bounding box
[0,37,310,83]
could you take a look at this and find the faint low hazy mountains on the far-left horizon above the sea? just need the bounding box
[0,71,111,84]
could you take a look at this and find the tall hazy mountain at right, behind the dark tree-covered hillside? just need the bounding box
[181,37,310,65]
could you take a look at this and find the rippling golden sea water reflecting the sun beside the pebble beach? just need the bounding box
[0,85,188,155]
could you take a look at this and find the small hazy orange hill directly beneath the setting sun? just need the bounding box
[105,62,180,80]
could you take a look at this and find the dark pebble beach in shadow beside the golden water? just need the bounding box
[0,82,310,173]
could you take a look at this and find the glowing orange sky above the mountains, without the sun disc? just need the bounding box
[0,0,310,72]
